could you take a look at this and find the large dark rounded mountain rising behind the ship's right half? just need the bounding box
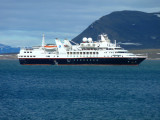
[73,11,160,49]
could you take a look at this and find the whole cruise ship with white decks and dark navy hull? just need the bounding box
[18,34,147,65]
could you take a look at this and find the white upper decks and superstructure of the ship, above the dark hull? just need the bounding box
[18,34,146,58]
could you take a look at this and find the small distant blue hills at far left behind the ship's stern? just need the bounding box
[0,44,20,54]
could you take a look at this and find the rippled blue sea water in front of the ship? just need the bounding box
[0,60,160,120]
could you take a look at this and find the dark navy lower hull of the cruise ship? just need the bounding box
[19,58,145,65]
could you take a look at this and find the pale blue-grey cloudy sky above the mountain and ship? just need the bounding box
[0,0,160,47]
